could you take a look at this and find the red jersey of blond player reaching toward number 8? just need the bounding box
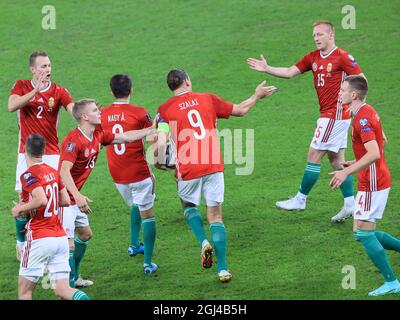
[59,126,115,205]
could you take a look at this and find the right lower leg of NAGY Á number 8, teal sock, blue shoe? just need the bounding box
[140,208,158,275]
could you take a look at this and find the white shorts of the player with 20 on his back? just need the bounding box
[19,236,71,282]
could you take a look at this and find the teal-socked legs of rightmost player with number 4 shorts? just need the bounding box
[353,220,400,296]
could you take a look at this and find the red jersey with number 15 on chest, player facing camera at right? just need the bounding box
[296,47,362,120]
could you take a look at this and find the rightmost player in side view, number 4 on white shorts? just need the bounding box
[330,76,400,296]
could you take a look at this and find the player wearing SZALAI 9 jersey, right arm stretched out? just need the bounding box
[155,69,276,282]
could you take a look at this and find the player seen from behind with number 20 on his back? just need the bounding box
[12,134,90,300]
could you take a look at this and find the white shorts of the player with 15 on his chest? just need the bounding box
[310,118,351,153]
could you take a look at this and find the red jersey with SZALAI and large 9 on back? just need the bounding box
[157,92,233,180]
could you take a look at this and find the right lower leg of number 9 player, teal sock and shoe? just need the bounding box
[207,205,233,283]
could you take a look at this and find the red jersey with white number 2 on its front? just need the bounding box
[11,80,73,155]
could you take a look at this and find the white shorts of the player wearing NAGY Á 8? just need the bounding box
[115,176,156,211]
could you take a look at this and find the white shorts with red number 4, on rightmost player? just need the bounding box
[354,188,390,222]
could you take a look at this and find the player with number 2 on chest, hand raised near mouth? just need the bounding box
[8,52,73,260]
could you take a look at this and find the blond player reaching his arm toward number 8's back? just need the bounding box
[60,99,155,287]
